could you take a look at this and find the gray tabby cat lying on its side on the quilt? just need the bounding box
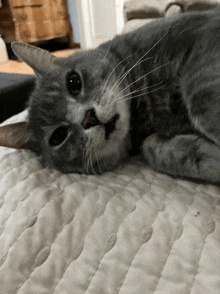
[12,8,220,182]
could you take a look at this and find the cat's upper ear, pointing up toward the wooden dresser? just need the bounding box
[11,42,62,75]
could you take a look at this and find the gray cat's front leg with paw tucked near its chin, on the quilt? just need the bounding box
[142,134,220,182]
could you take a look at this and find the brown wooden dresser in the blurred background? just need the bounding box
[0,0,74,47]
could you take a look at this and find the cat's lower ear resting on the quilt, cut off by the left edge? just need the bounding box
[0,122,39,151]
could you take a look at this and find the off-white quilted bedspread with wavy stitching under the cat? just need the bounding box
[0,113,220,294]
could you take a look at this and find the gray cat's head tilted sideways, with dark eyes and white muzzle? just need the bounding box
[12,42,130,173]
